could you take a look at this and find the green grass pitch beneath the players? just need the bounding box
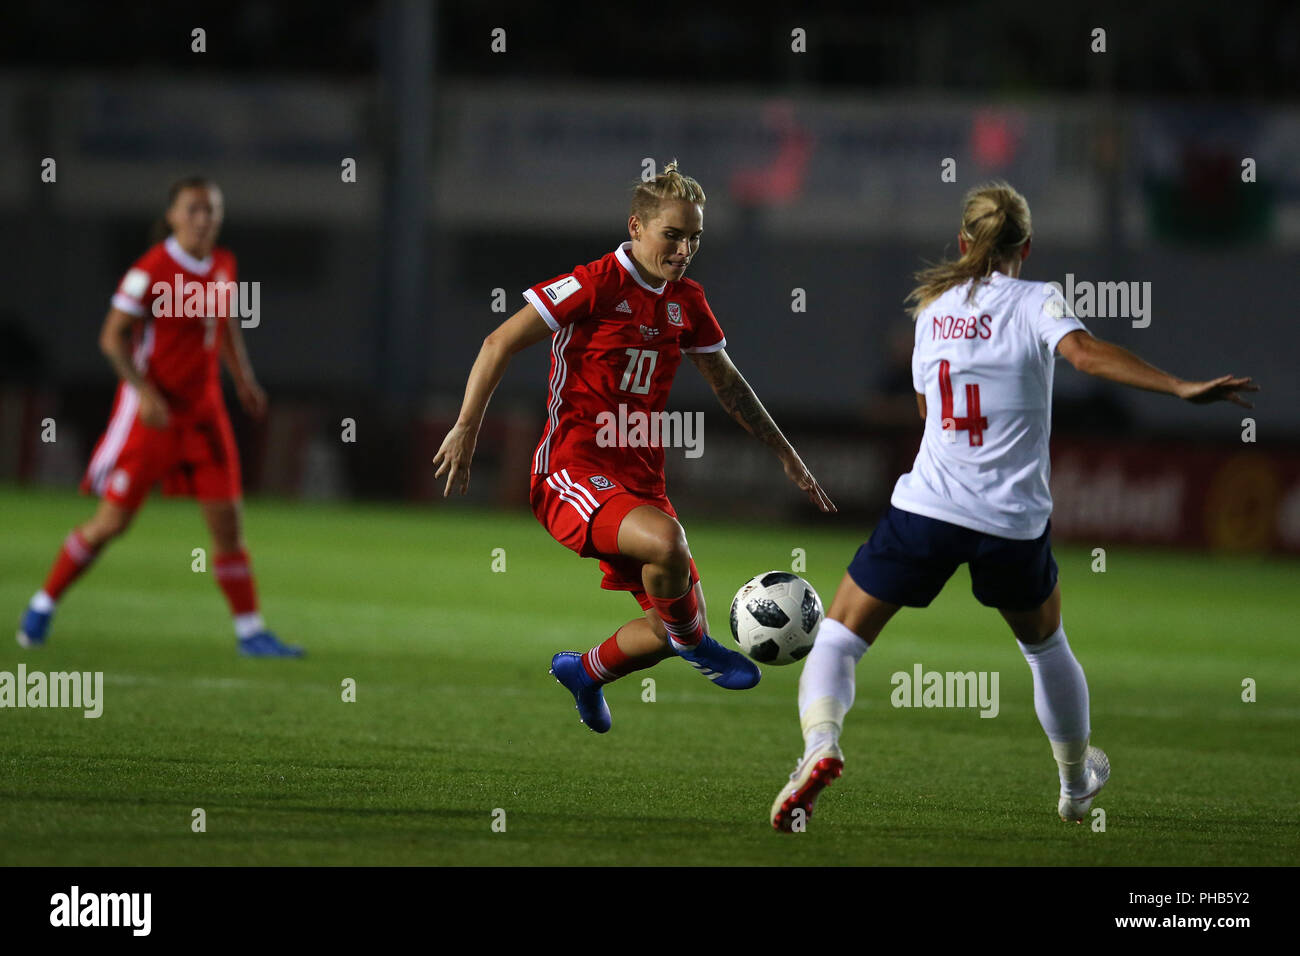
[0,486,1300,865]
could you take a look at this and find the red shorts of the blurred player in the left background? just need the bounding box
[81,386,239,510]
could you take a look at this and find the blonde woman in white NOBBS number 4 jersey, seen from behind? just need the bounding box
[771,182,1257,831]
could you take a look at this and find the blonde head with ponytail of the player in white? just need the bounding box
[904,182,1032,319]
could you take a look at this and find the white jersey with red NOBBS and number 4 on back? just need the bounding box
[891,272,1084,540]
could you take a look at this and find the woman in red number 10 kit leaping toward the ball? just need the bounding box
[433,163,835,734]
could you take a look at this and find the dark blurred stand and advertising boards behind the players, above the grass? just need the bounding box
[0,0,1300,551]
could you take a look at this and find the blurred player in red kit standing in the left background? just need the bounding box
[18,177,303,657]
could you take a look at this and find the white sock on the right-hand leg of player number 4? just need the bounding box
[1017,622,1092,796]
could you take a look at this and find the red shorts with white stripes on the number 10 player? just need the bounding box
[532,468,699,610]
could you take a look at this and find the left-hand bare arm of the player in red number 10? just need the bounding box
[433,306,551,498]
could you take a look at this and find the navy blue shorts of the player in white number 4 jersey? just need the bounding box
[849,505,1057,611]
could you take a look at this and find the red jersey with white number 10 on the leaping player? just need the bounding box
[524,242,727,494]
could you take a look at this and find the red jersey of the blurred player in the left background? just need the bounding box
[113,237,238,416]
